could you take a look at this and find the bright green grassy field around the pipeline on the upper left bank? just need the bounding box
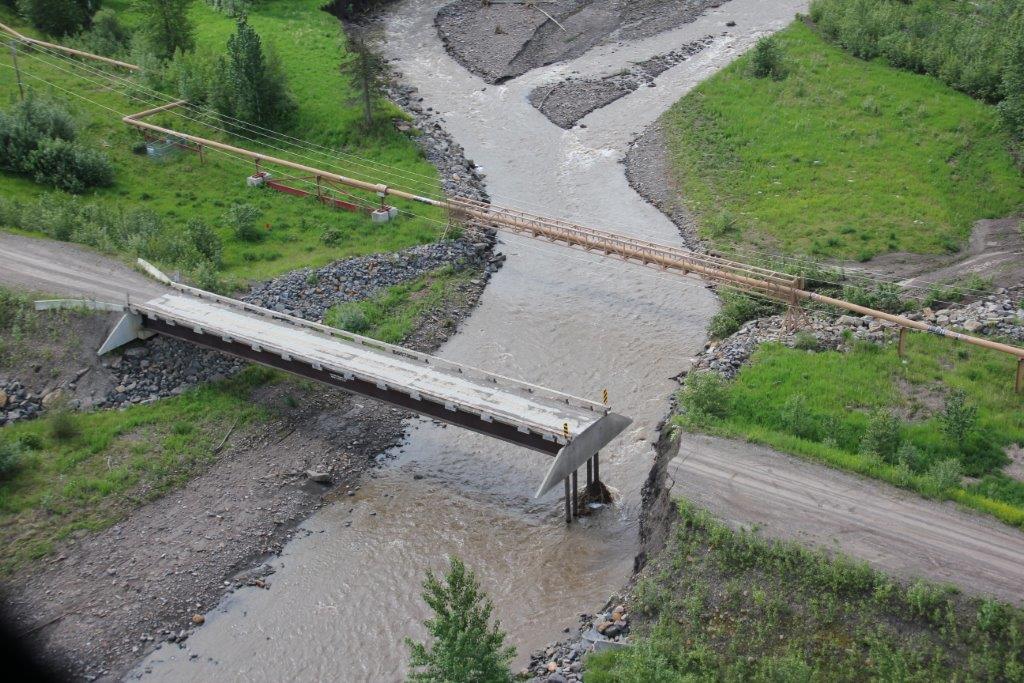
[0,0,442,284]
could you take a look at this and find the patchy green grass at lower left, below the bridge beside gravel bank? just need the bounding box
[0,368,273,573]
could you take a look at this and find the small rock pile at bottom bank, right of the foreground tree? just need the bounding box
[521,603,630,683]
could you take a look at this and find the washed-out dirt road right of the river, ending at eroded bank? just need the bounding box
[669,434,1024,604]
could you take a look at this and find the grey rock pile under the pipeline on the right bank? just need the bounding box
[692,286,1024,378]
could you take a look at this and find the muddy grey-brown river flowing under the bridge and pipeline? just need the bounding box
[135,0,804,681]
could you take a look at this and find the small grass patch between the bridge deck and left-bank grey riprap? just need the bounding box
[324,266,477,344]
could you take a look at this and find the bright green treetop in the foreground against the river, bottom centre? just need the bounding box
[406,557,515,683]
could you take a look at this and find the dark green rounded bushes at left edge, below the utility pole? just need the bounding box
[0,97,114,194]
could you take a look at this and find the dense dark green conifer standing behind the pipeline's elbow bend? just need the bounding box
[211,16,295,128]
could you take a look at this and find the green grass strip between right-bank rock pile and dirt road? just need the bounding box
[676,335,1024,527]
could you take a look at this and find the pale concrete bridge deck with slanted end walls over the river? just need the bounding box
[99,284,630,495]
